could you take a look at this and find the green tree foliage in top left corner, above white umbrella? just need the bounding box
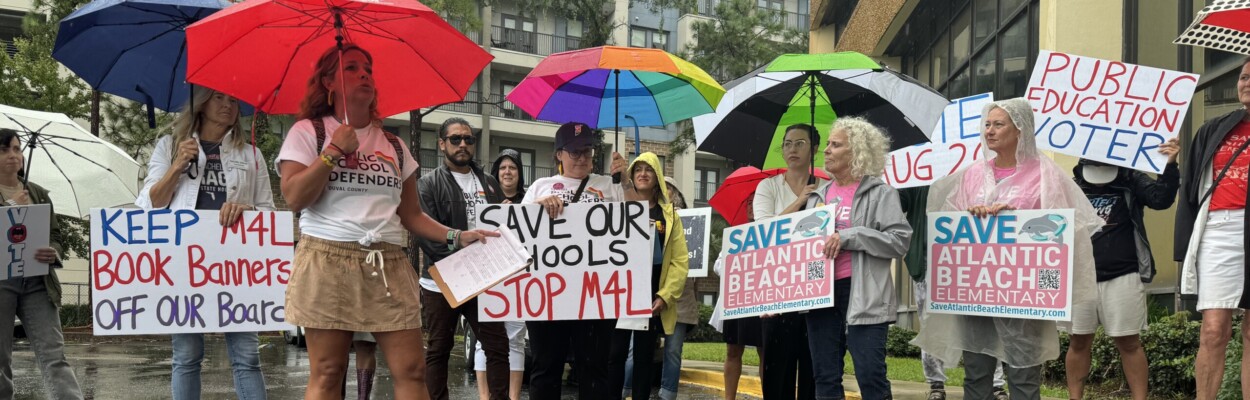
[0,0,91,119]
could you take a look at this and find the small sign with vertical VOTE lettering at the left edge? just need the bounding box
[0,204,53,280]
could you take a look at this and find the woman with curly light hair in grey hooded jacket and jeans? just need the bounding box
[805,118,911,399]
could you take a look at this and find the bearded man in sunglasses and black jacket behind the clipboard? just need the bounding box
[416,118,509,400]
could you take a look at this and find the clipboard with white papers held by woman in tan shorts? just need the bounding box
[430,229,534,308]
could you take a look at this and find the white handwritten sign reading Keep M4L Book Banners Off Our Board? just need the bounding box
[91,209,295,335]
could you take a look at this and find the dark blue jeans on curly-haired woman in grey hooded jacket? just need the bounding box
[808,279,893,400]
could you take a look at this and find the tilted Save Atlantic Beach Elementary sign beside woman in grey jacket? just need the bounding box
[720,205,835,319]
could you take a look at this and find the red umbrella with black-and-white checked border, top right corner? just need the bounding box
[1173,0,1250,54]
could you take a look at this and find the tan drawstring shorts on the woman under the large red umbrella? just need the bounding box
[286,235,421,333]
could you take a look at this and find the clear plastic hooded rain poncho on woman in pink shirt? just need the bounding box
[914,98,1104,368]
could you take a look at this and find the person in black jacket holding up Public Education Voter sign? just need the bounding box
[1065,146,1180,400]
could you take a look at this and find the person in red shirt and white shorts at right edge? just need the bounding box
[1174,58,1250,400]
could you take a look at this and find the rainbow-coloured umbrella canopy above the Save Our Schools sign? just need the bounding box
[508,46,725,150]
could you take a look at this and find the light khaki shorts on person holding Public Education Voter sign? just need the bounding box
[1061,274,1146,338]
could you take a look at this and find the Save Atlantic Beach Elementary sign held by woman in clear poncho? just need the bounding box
[925,209,1074,321]
